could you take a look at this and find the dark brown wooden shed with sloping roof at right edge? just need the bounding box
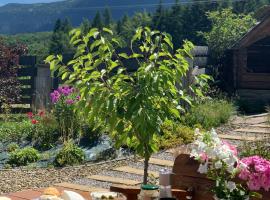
[227,12,270,104]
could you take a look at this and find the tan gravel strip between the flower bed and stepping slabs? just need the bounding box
[0,158,131,194]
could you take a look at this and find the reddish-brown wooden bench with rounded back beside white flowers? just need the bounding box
[110,154,270,200]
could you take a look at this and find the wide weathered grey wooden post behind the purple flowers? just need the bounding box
[32,64,53,111]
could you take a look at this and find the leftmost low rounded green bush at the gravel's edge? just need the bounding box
[7,147,40,167]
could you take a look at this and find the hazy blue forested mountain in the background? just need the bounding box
[0,0,175,34]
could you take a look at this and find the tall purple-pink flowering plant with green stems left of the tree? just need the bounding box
[51,86,80,141]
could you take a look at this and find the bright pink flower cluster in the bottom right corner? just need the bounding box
[239,156,270,191]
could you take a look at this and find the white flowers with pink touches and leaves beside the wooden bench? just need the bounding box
[191,130,258,200]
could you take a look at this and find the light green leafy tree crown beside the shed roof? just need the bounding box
[203,9,256,59]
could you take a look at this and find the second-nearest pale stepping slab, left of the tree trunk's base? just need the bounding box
[87,175,141,185]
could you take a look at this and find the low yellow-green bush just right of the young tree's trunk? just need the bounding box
[158,121,194,149]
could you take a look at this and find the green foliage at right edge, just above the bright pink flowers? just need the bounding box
[240,140,270,160]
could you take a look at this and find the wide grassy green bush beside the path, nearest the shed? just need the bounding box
[182,99,236,130]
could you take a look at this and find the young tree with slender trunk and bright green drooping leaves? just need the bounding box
[47,28,209,184]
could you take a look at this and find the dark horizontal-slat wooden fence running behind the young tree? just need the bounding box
[10,46,208,112]
